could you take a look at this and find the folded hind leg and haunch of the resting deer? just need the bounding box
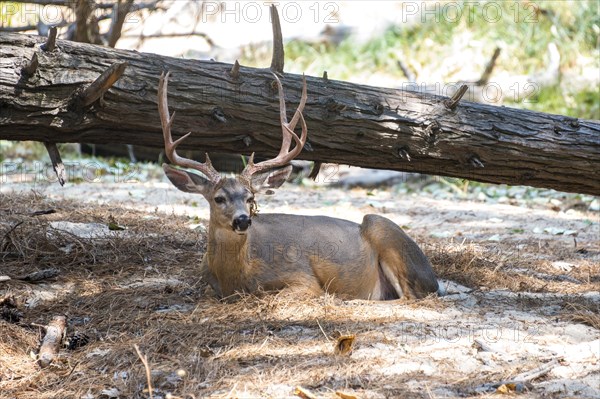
[361,215,439,299]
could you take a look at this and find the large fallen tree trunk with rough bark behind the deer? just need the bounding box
[0,33,600,195]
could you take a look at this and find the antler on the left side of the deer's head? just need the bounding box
[158,72,221,183]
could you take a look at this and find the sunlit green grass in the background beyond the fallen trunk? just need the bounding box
[268,1,600,119]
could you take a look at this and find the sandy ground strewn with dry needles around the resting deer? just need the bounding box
[0,169,600,399]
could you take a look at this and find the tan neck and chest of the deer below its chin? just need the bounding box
[207,227,250,296]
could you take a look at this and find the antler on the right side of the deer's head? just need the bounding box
[242,74,308,178]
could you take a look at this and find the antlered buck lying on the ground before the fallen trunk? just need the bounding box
[158,72,442,300]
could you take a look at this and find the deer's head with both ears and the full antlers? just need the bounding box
[158,73,308,234]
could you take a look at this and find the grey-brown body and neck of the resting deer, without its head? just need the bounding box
[203,209,438,300]
